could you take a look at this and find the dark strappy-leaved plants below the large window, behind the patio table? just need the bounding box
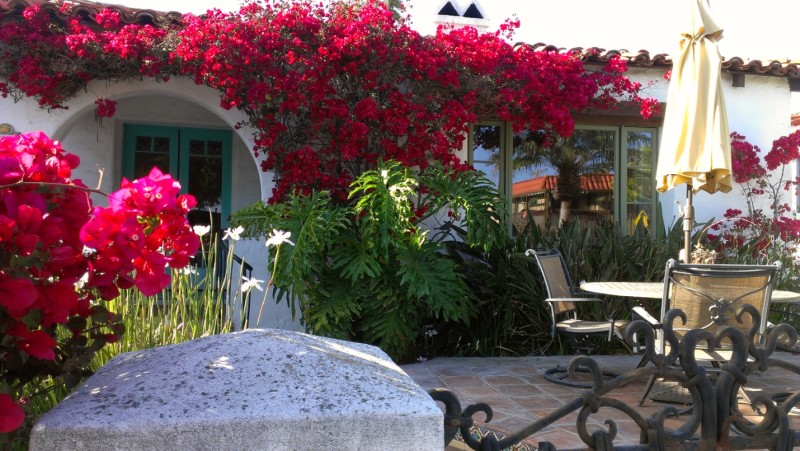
[427,217,682,355]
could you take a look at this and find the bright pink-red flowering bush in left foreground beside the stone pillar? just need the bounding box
[0,132,199,443]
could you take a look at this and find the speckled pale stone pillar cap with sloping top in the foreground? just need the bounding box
[30,329,443,451]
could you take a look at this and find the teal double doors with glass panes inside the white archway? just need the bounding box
[122,124,232,227]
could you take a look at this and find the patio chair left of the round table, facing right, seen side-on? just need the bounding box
[525,249,628,387]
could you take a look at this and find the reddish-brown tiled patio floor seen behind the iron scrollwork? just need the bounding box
[402,352,800,449]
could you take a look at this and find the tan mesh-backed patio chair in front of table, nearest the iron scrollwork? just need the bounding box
[633,260,781,405]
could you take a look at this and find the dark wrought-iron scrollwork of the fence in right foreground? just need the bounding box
[429,304,800,451]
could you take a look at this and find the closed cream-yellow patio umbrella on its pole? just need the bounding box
[656,0,732,262]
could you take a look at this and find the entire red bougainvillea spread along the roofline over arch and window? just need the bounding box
[0,0,654,201]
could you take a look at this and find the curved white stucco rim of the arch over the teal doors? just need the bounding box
[39,77,273,199]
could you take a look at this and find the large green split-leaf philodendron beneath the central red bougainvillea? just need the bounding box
[233,162,508,360]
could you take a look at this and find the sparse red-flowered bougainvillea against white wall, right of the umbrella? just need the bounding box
[708,131,800,284]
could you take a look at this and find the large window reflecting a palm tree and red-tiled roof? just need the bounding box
[470,122,657,237]
